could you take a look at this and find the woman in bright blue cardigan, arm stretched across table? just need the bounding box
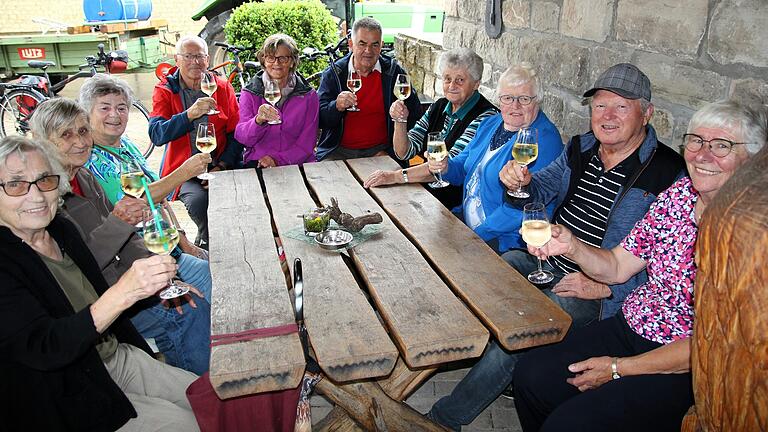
[364,63,563,253]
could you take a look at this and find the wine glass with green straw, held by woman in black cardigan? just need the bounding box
[142,207,189,300]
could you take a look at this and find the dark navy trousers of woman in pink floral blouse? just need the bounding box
[514,313,693,432]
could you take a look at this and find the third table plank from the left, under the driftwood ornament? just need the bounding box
[304,161,488,367]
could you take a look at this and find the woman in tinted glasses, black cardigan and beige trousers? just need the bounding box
[0,137,198,431]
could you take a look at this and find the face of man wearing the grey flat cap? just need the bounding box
[591,90,653,150]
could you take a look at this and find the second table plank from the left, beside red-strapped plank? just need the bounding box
[263,166,398,382]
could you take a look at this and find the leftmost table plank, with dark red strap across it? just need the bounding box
[208,170,305,398]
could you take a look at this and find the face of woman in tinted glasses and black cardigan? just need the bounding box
[0,151,59,239]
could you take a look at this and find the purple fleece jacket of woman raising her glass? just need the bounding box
[235,72,319,165]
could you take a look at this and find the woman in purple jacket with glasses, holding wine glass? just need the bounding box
[235,33,319,168]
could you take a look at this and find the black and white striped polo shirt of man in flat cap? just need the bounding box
[549,146,640,273]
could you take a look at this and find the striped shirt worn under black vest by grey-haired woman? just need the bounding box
[403,92,496,160]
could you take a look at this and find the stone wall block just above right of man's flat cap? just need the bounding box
[637,54,728,109]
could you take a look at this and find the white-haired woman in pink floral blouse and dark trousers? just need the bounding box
[514,101,768,431]
